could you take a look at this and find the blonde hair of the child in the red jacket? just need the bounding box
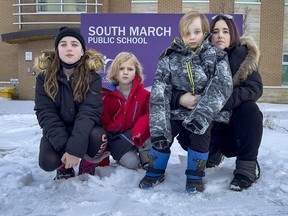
[106,52,144,85]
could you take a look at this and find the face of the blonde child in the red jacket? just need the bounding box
[117,59,136,85]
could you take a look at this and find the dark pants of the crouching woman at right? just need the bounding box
[209,101,263,161]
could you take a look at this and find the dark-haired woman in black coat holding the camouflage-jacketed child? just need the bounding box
[173,15,263,191]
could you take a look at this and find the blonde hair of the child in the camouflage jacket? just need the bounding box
[178,11,210,38]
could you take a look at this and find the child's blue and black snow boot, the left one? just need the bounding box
[139,148,170,189]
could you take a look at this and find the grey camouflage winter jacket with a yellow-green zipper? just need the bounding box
[150,35,233,148]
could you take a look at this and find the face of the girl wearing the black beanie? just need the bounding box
[58,36,84,64]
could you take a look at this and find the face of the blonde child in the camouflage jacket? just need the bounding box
[182,17,203,50]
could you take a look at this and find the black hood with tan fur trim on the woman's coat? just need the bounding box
[228,37,260,86]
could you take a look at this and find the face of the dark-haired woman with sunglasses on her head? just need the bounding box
[211,20,231,50]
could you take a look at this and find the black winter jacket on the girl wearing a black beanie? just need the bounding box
[34,51,103,158]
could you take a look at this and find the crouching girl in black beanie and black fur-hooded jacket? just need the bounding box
[34,27,109,179]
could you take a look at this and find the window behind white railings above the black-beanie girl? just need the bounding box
[37,0,87,12]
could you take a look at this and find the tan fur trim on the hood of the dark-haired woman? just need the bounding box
[229,37,260,86]
